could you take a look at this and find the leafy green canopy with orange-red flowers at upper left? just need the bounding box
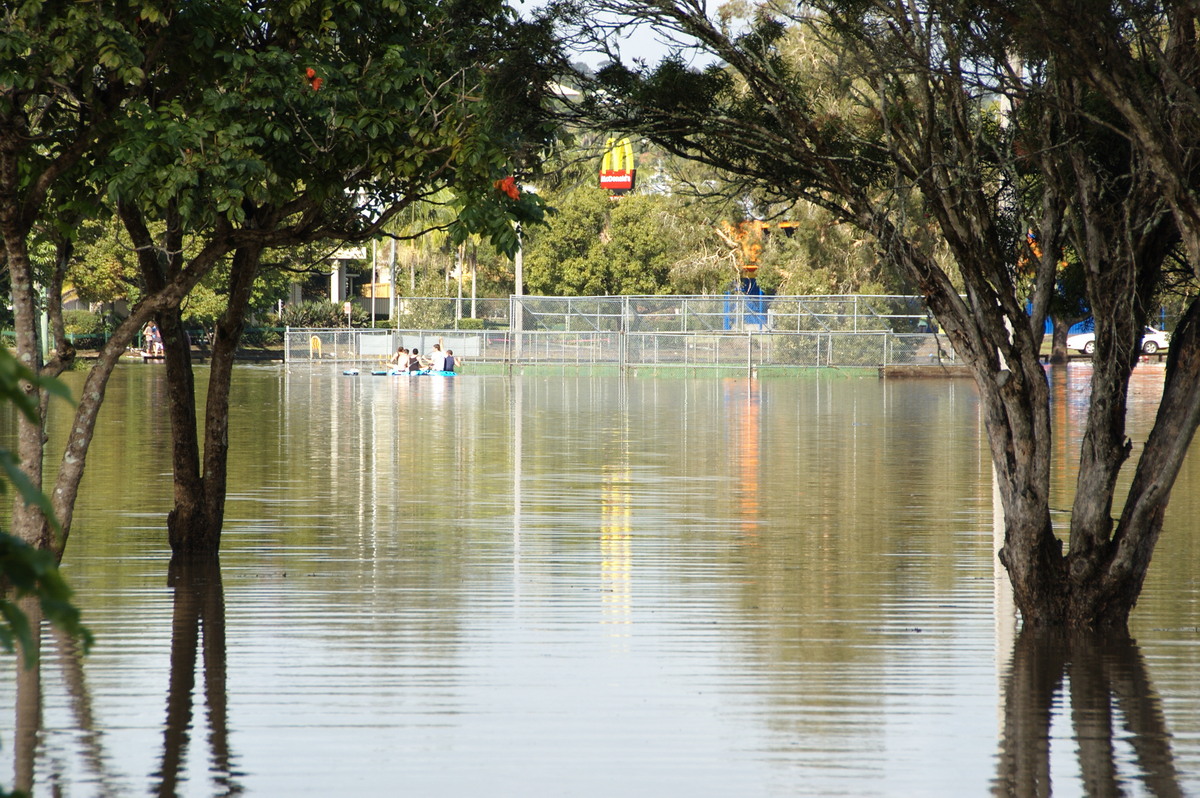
[0,0,566,553]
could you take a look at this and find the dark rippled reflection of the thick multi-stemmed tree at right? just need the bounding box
[994,629,1183,797]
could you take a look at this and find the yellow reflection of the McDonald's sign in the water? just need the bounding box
[600,466,634,636]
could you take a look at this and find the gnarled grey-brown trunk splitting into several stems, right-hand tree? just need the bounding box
[862,121,1180,629]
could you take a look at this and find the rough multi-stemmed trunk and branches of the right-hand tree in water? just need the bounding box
[838,43,1200,629]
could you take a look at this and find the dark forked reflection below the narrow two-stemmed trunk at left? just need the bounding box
[154,557,242,796]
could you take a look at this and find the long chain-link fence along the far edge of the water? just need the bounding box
[284,294,954,372]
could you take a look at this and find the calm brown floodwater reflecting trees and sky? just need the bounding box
[0,365,1200,798]
